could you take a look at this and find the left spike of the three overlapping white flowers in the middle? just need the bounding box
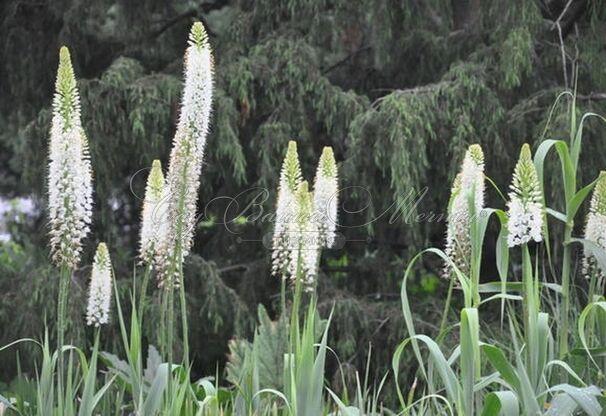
[272,141,303,277]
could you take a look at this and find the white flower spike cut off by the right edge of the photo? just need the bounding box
[583,171,606,283]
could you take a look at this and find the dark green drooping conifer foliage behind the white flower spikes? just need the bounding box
[0,0,606,396]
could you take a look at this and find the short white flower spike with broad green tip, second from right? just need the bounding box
[507,143,544,247]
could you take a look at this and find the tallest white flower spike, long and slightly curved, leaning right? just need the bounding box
[167,22,213,286]
